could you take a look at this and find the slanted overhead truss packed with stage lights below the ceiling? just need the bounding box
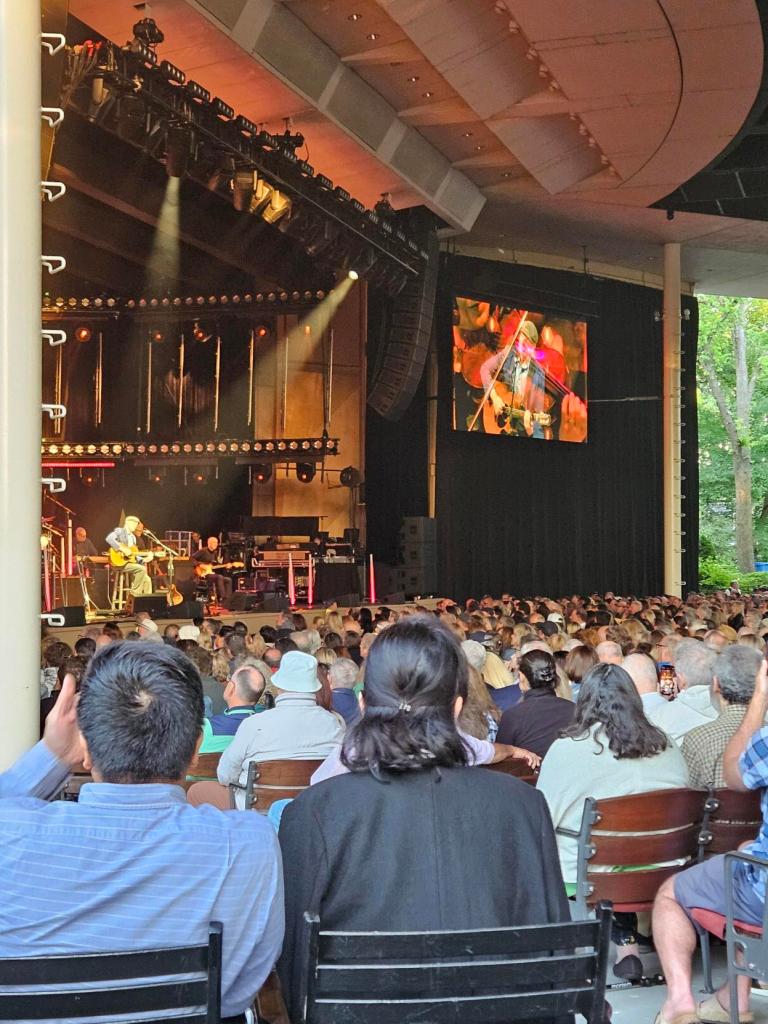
[62,23,428,295]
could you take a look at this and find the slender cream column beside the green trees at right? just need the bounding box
[663,242,683,597]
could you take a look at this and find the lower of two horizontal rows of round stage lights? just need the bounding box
[41,437,339,458]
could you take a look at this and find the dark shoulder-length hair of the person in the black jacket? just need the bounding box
[341,615,469,778]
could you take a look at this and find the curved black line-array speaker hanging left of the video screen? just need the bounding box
[368,230,439,420]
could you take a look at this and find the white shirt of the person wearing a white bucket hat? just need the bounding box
[218,693,344,807]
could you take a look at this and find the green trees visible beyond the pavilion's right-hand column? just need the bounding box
[697,296,768,572]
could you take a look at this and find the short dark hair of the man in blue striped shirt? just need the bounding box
[78,640,203,783]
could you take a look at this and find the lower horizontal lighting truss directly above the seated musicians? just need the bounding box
[41,437,339,469]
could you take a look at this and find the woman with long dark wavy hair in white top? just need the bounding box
[537,664,688,981]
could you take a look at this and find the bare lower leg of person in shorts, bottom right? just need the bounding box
[652,879,696,1020]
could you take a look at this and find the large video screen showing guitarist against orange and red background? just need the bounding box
[452,297,589,443]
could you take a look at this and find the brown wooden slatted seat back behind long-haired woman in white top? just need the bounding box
[575,790,707,915]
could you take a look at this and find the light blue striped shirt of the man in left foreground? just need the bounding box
[0,743,284,1017]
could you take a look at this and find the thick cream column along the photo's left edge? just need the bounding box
[0,0,41,769]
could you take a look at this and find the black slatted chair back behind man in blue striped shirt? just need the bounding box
[0,921,222,1024]
